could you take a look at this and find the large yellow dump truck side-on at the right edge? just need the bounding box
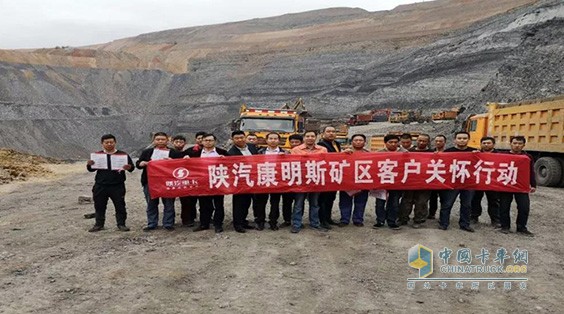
[466,96,564,186]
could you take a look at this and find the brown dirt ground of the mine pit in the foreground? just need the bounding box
[0,163,564,313]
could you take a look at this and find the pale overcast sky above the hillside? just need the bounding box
[0,0,422,49]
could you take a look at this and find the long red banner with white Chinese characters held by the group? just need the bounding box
[147,152,530,197]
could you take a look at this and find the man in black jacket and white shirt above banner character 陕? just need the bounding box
[188,133,227,233]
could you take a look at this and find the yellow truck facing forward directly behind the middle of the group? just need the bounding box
[232,99,309,149]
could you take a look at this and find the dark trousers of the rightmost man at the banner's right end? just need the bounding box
[499,192,531,231]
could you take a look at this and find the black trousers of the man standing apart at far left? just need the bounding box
[92,183,127,226]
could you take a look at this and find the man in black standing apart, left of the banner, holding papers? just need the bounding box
[86,134,134,232]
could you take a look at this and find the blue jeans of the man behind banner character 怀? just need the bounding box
[439,190,474,228]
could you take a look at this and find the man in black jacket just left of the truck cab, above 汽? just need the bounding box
[227,130,264,233]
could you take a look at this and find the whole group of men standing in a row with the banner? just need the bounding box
[87,126,536,236]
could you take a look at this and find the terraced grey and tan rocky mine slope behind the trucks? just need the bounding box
[0,0,564,158]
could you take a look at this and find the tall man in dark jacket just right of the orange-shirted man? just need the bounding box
[317,126,352,229]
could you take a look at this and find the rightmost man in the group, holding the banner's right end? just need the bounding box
[499,136,537,237]
